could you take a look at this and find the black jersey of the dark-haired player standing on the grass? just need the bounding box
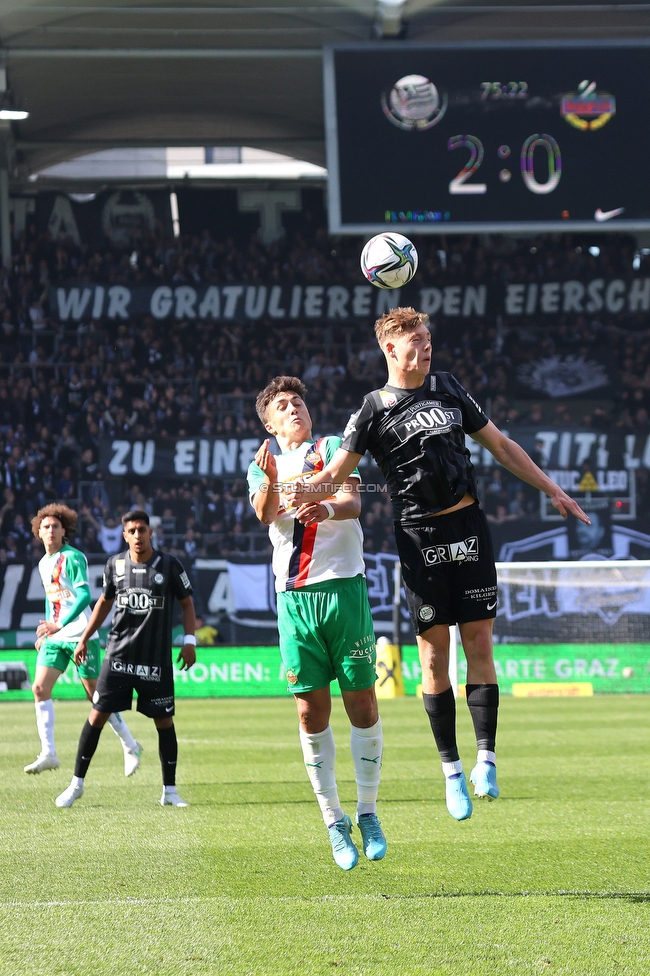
[103,549,192,668]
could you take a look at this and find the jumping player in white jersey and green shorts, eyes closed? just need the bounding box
[248,376,386,871]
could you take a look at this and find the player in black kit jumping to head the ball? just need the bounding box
[288,308,589,820]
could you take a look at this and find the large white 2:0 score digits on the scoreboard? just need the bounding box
[447,132,562,195]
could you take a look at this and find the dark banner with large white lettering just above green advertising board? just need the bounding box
[0,540,650,649]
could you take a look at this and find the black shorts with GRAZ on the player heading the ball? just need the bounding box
[395,503,497,634]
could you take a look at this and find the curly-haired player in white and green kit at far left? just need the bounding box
[25,503,142,776]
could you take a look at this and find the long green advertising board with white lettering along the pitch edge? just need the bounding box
[0,643,650,702]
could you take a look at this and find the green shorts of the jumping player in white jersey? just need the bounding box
[277,576,377,693]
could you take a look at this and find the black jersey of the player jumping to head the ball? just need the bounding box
[341,373,488,524]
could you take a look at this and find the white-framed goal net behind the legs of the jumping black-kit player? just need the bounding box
[449,559,650,695]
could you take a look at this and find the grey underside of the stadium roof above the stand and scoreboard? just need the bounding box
[0,0,650,183]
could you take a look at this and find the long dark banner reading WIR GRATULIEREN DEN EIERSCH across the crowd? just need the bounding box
[49,274,650,322]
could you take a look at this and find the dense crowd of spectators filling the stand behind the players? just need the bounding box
[0,215,650,563]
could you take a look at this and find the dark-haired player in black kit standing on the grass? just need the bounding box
[55,509,196,807]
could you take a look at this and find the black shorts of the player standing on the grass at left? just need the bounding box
[93,657,174,718]
